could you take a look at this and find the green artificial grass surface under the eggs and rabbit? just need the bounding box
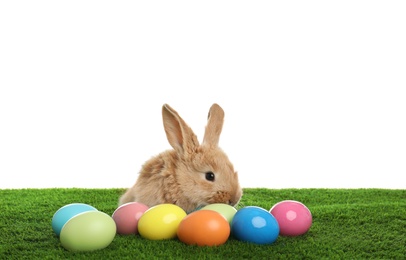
[0,188,406,259]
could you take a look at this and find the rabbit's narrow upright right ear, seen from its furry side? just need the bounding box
[203,104,224,146]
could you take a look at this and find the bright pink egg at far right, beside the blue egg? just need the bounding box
[269,200,313,236]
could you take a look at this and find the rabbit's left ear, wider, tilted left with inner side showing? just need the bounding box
[162,104,199,154]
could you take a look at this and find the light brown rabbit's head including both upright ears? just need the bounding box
[162,104,242,210]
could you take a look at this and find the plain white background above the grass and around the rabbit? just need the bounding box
[0,0,406,189]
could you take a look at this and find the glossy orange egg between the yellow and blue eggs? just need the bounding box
[177,209,230,246]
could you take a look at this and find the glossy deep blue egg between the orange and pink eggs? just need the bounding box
[231,206,279,244]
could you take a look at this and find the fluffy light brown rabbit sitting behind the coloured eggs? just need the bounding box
[119,104,242,213]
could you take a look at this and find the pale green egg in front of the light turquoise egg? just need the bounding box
[60,211,116,251]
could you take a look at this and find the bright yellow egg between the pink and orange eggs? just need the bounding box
[138,204,186,240]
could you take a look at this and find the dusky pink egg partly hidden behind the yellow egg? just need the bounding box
[112,202,149,235]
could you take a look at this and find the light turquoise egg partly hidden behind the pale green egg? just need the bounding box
[52,203,97,236]
